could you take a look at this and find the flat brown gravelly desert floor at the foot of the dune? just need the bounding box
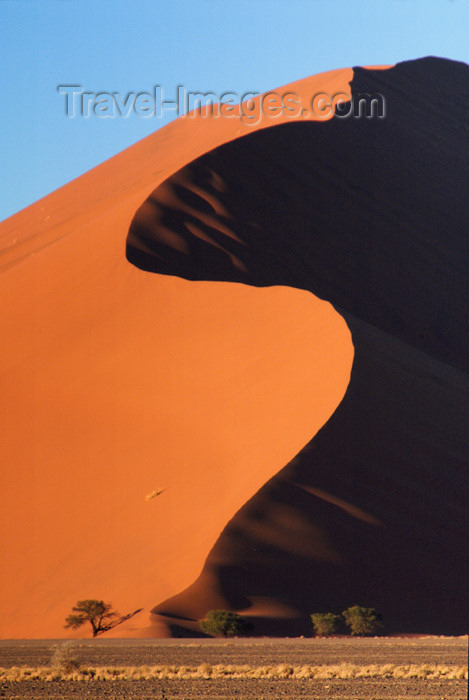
[0,637,468,700]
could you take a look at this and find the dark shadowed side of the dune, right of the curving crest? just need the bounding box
[127,58,469,634]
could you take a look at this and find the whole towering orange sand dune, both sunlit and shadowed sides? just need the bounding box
[0,58,469,637]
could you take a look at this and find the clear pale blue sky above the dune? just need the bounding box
[0,0,469,219]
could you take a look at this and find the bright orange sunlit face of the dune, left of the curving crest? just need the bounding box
[0,70,353,637]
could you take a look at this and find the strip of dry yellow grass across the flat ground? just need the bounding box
[0,663,468,682]
